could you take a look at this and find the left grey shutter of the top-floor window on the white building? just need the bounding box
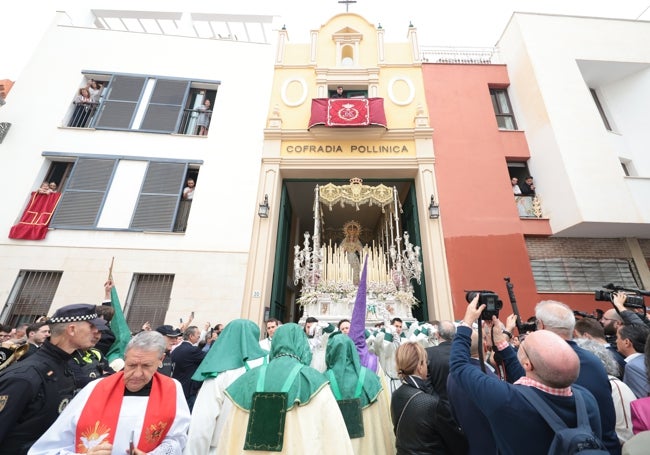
[95,76,146,129]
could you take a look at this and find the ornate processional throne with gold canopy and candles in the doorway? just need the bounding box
[294,177,422,327]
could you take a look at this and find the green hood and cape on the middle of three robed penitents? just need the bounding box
[226,322,327,411]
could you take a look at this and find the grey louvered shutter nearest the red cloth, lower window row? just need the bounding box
[51,158,115,228]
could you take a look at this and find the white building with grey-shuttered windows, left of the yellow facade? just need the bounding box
[0,6,275,329]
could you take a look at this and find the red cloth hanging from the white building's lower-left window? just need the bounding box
[9,191,61,240]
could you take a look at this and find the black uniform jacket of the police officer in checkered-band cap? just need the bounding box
[0,341,75,455]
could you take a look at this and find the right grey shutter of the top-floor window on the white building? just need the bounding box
[140,79,188,133]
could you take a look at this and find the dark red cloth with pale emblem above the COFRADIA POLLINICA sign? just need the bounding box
[308,98,386,128]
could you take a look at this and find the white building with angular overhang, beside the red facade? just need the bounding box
[498,13,650,309]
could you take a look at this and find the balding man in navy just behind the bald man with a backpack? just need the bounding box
[535,300,621,455]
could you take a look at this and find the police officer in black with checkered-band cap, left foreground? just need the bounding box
[0,304,103,455]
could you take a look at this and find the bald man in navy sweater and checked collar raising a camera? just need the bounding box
[449,296,601,455]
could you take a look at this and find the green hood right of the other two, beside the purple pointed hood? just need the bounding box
[325,333,381,408]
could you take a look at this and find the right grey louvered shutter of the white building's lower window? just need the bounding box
[131,162,187,232]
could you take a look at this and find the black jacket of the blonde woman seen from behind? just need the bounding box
[390,376,468,455]
